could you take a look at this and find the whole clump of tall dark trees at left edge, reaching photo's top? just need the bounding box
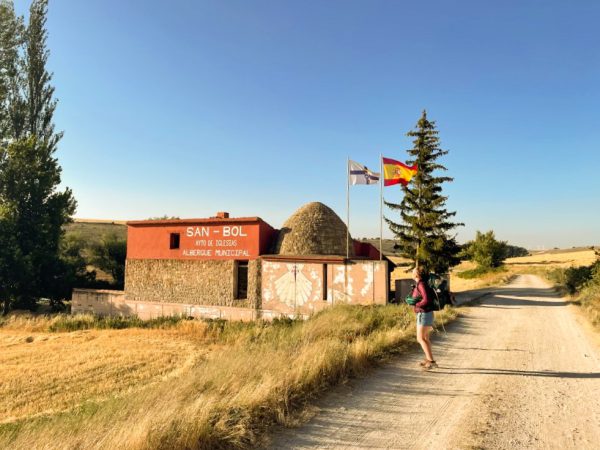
[0,0,76,311]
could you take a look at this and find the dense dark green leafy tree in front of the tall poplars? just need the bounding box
[0,137,75,308]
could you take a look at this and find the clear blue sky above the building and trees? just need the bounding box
[15,0,600,248]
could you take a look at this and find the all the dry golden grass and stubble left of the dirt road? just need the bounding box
[0,305,457,449]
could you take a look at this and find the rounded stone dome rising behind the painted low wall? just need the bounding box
[275,202,354,256]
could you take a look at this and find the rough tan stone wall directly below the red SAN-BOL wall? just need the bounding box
[125,259,260,309]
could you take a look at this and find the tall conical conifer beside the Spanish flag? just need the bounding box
[385,111,462,273]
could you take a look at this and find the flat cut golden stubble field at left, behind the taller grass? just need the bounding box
[0,318,202,423]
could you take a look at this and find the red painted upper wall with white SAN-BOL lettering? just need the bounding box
[127,217,274,260]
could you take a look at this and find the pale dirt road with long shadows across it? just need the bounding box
[270,275,600,449]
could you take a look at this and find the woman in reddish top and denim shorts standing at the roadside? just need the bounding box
[411,267,437,370]
